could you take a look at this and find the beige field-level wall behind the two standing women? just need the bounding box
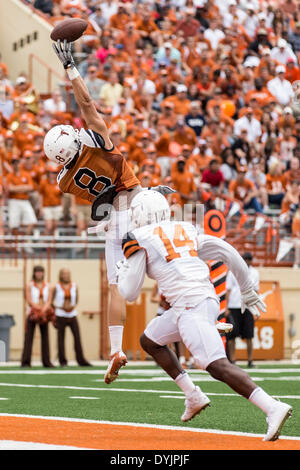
[0,260,300,361]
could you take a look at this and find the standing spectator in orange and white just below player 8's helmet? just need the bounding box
[39,165,62,235]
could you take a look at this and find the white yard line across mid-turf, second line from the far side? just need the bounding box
[0,383,300,400]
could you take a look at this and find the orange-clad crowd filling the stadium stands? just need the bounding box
[0,0,300,258]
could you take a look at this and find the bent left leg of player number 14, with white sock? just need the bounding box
[140,309,210,421]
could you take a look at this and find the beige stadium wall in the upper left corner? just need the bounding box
[0,0,63,93]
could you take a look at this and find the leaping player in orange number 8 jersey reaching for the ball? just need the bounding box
[44,41,166,383]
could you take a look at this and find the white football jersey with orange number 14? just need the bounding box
[122,222,218,307]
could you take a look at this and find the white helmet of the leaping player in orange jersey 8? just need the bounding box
[44,125,81,165]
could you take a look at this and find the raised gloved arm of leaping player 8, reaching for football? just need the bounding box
[53,40,113,148]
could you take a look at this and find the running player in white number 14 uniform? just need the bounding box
[118,191,292,441]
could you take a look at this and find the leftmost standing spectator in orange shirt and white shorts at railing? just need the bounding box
[6,157,37,235]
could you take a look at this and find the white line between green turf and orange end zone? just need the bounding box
[0,413,300,441]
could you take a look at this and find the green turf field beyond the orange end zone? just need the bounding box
[0,364,300,437]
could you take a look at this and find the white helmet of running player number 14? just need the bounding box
[130,190,171,230]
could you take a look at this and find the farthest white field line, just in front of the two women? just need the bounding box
[0,367,300,377]
